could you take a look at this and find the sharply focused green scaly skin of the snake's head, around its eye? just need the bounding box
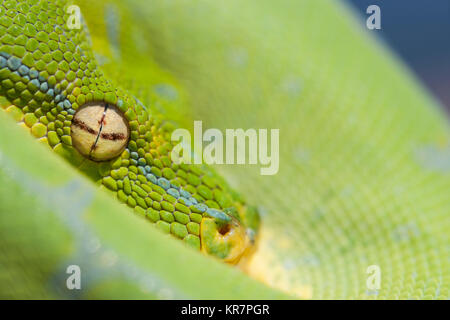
[0,0,259,263]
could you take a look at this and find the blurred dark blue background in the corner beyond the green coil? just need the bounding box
[347,0,450,115]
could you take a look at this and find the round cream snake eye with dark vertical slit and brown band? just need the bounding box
[70,103,130,161]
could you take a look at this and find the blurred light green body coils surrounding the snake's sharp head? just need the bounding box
[0,0,450,299]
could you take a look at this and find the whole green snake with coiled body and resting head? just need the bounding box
[0,0,450,299]
